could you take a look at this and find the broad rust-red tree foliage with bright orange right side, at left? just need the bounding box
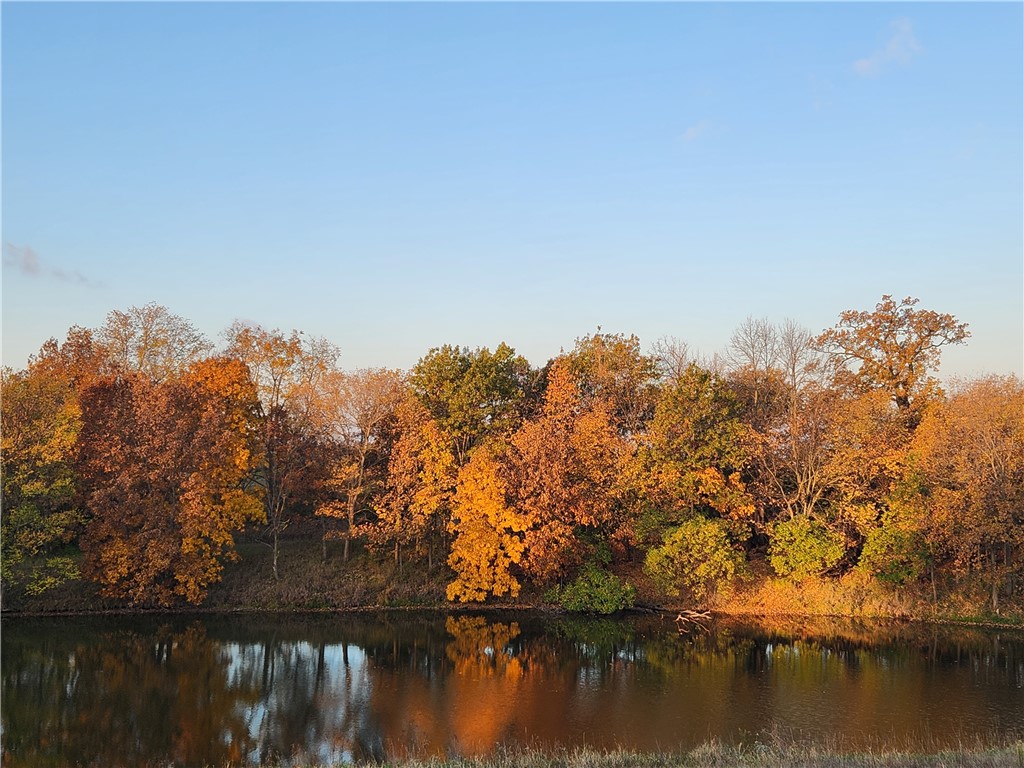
[78,359,261,606]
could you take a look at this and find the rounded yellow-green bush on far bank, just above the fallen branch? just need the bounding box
[644,517,744,601]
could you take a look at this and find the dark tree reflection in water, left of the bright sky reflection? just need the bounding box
[3,624,256,766]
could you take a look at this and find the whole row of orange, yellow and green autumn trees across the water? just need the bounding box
[0,296,1024,610]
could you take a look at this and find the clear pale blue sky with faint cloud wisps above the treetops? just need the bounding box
[0,2,1024,376]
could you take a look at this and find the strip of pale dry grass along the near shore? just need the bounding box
[256,742,1024,768]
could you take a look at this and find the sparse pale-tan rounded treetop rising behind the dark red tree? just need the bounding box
[96,302,213,381]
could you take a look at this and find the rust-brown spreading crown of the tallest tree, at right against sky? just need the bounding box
[815,295,970,413]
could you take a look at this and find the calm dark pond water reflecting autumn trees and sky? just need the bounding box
[0,613,1024,766]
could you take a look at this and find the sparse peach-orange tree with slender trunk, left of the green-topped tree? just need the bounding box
[316,369,407,562]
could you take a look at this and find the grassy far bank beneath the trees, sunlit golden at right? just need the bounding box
[3,538,1024,626]
